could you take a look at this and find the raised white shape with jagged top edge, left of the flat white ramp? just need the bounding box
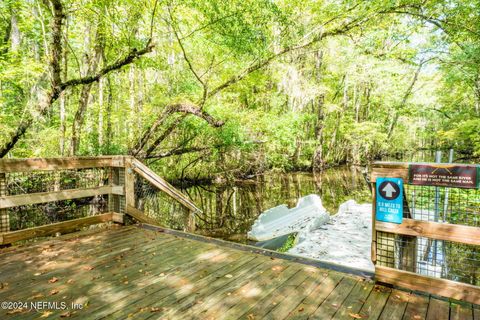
[247,194,330,241]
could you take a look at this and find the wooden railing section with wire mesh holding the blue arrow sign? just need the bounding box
[371,163,480,304]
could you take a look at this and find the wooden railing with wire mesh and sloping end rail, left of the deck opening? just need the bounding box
[0,156,200,245]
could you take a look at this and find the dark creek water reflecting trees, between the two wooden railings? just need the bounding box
[182,167,371,242]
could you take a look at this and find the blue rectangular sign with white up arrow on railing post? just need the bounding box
[375,178,403,223]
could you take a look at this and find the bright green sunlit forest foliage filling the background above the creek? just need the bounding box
[0,0,480,178]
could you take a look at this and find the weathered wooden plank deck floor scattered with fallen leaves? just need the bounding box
[0,226,480,320]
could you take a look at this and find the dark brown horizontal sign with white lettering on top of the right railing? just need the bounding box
[408,163,480,189]
